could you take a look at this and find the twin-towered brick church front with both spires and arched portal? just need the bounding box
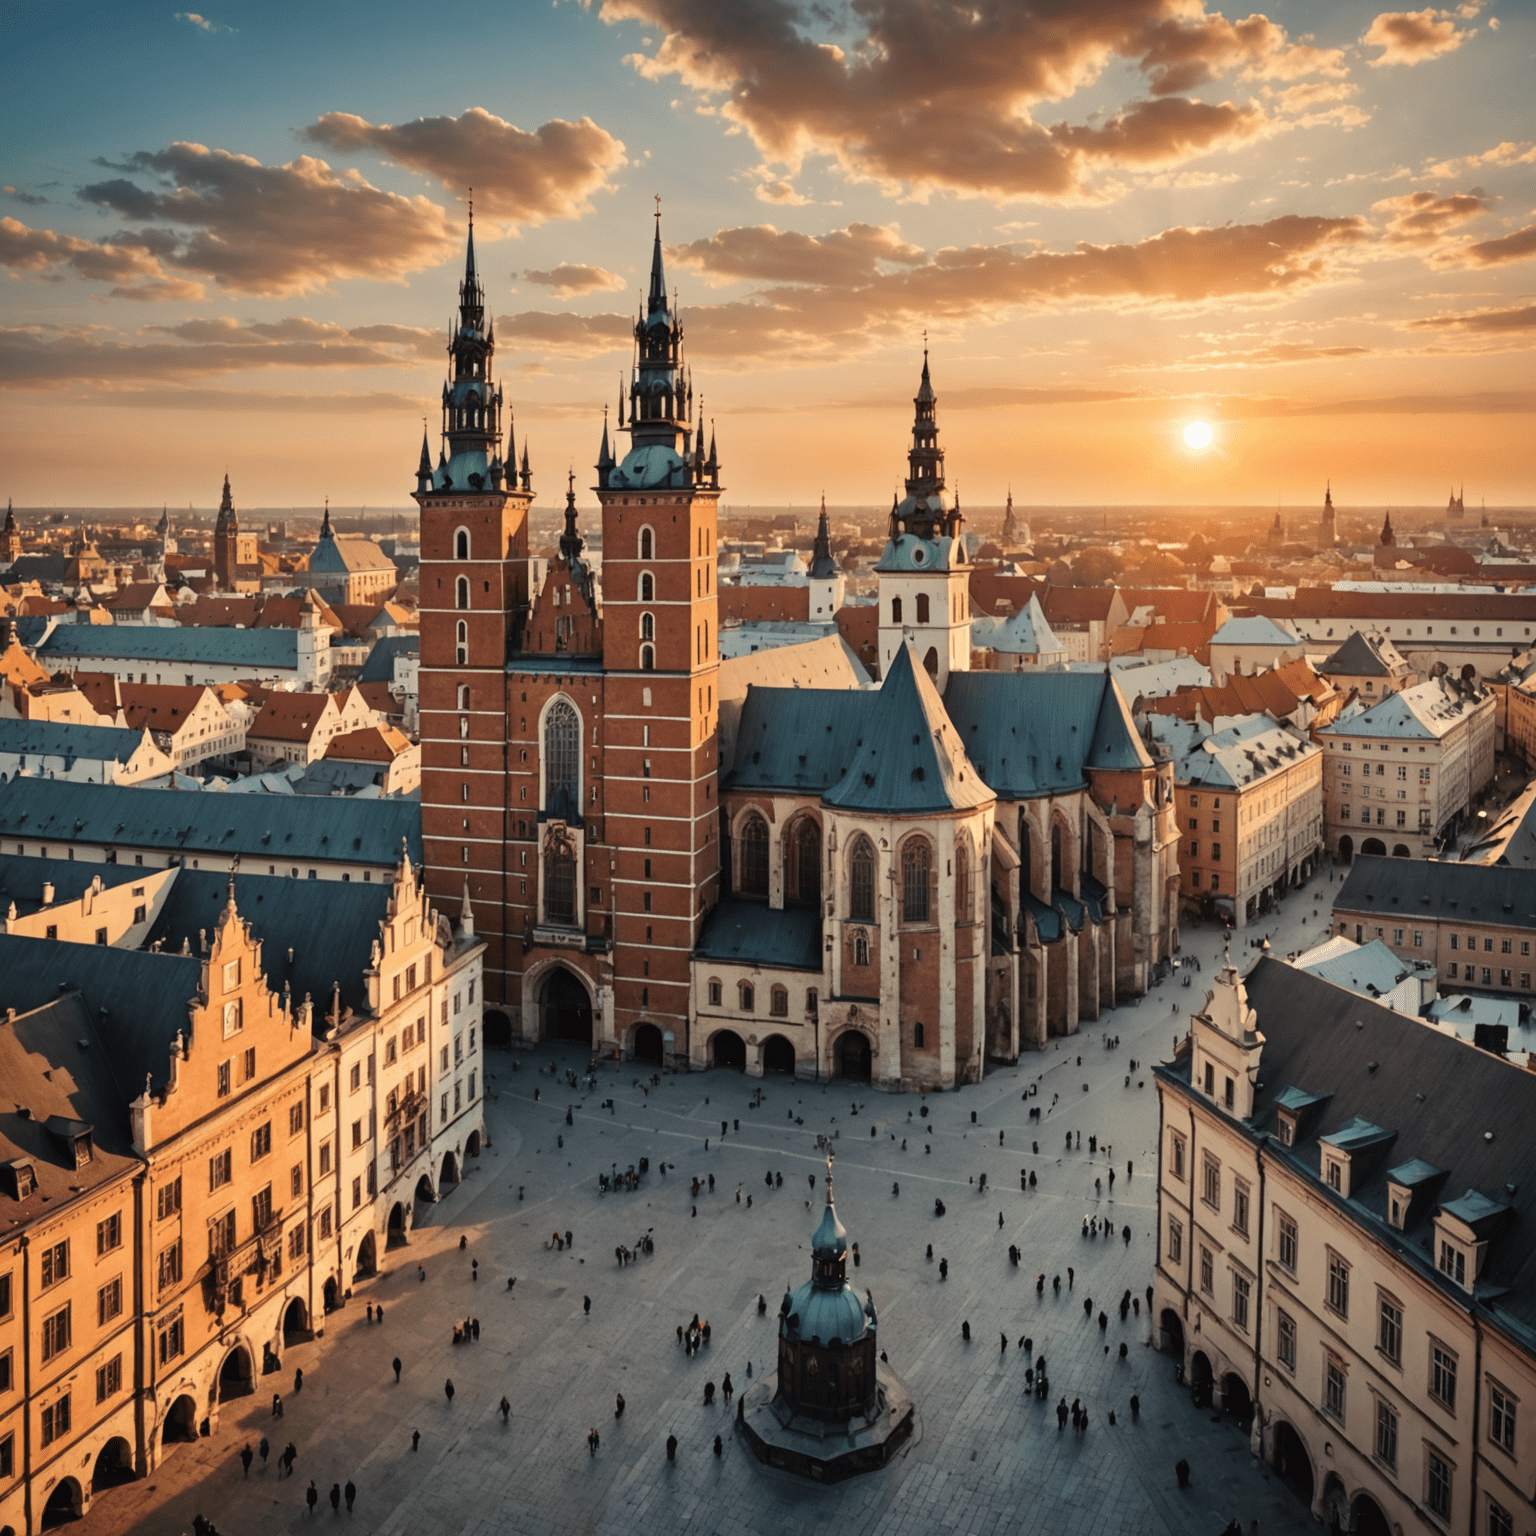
[416,210,720,1060]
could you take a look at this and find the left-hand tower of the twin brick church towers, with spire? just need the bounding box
[415,210,533,998]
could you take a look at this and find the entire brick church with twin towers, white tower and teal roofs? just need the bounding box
[415,216,1178,1089]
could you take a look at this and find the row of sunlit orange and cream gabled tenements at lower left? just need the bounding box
[0,854,484,1530]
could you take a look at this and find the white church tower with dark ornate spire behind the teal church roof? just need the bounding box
[876,347,971,693]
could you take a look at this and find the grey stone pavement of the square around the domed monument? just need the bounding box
[81,871,1335,1536]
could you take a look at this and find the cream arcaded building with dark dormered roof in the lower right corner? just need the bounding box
[1154,958,1536,1536]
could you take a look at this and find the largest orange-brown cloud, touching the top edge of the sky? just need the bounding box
[585,0,1344,201]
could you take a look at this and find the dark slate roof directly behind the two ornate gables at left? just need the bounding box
[145,866,390,1028]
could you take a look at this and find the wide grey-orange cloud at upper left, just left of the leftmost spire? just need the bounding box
[80,143,459,296]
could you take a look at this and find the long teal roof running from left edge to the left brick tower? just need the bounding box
[0,779,421,872]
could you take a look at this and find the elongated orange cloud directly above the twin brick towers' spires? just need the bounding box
[304,106,624,226]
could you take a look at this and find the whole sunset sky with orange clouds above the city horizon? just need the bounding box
[0,0,1536,507]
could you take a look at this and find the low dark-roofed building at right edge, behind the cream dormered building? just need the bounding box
[1333,857,1536,997]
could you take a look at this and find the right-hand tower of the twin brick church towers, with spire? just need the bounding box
[596,214,720,1060]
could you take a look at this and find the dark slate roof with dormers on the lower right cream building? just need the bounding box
[1228,952,1536,1347]
